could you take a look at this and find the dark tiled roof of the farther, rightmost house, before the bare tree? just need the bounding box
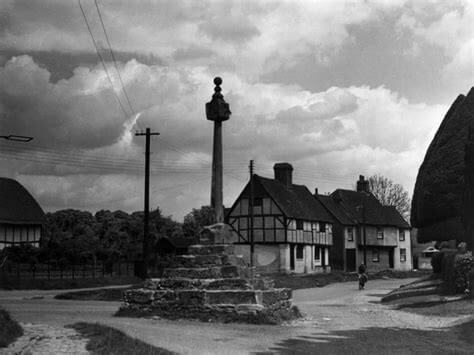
[330,189,410,228]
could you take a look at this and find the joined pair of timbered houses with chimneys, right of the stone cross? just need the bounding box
[226,163,413,273]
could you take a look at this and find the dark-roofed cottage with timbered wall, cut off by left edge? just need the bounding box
[0,178,45,250]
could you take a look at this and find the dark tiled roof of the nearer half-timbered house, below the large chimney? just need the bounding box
[254,175,334,223]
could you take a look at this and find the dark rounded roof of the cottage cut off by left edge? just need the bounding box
[0,178,45,223]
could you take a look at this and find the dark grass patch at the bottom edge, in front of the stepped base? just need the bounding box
[68,322,175,355]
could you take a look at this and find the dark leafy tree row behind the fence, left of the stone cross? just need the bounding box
[0,208,187,265]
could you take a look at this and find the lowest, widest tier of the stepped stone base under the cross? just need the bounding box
[117,288,301,324]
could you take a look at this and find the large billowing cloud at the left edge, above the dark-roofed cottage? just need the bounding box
[0,56,126,148]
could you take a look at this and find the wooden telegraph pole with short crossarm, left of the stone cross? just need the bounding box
[135,128,160,278]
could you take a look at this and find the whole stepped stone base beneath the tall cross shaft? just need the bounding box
[117,238,300,324]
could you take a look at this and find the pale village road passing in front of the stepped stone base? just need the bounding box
[0,279,474,354]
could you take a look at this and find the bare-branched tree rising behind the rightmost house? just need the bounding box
[368,174,411,221]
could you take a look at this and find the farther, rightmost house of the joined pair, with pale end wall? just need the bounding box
[317,176,413,271]
